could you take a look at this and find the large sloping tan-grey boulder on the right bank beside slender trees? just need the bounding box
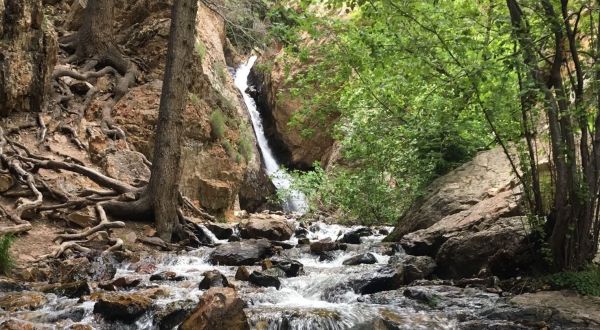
[386,148,533,278]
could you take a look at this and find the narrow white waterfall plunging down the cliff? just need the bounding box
[234,56,307,213]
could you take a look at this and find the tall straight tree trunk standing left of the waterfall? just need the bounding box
[146,0,198,241]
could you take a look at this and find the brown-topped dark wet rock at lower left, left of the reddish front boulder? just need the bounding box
[94,292,152,324]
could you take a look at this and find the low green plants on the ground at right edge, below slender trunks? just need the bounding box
[548,265,600,296]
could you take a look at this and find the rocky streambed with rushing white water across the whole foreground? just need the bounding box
[0,214,600,329]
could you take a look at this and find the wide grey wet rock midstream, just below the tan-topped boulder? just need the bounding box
[210,239,272,266]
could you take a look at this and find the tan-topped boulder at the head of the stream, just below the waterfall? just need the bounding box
[240,213,294,241]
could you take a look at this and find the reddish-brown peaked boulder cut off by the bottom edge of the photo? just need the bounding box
[179,288,249,330]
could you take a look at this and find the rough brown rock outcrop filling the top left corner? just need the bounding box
[0,0,58,117]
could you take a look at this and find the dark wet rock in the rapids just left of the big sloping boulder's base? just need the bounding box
[350,266,404,294]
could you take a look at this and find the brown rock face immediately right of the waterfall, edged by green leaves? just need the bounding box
[250,55,335,168]
